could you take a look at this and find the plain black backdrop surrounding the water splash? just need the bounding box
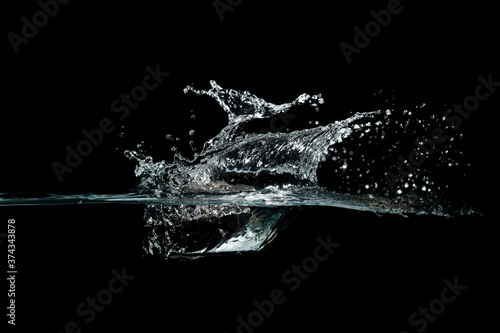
[0,0,500,332]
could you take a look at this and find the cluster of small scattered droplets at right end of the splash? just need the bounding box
[318,104,464,200]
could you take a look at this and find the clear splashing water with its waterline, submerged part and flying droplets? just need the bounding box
[0,81,473,257]
